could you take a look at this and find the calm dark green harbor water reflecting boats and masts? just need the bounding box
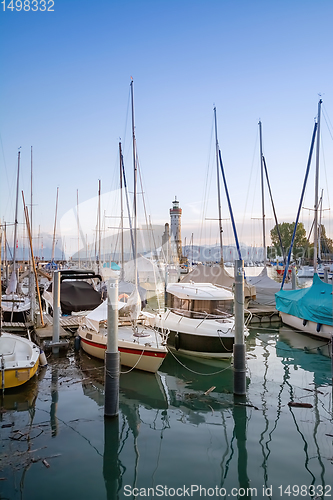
[0,325,333,500]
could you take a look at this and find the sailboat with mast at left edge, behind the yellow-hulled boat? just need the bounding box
[1,151,30,322]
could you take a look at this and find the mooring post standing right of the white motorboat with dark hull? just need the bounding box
[233,260,246,396]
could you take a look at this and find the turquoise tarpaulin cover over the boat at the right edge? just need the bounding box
[275,274,333,325]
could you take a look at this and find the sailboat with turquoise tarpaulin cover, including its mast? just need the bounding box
[275,99,333,339]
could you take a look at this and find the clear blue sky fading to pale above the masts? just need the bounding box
[0,0,333,258]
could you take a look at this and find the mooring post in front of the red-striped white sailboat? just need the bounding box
[104,278,120,417]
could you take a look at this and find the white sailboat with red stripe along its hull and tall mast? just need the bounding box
[78,80,168,373]
